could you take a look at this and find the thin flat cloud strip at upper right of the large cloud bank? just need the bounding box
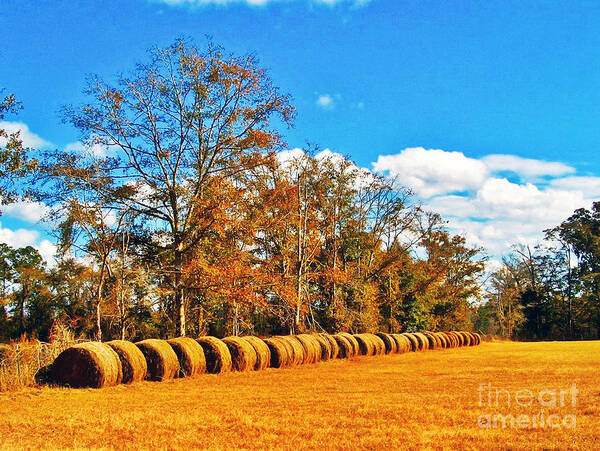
[481,154,575,178]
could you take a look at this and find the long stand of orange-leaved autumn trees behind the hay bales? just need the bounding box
[0,40,483,340]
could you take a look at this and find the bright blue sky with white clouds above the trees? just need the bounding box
[0,0,600,264]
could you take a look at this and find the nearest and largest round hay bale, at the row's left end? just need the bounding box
[50,341,123,388]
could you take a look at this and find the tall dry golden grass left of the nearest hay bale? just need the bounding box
[0,326,77,392]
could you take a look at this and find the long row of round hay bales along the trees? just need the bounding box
[43,332,481,388]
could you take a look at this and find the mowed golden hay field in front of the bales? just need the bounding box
[0,342,600,449]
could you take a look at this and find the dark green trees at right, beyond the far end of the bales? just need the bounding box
[477,202,600,340]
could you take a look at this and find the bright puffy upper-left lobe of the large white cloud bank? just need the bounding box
[373,147,489,198]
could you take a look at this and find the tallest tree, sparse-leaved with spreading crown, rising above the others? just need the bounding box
[46,40,294,335]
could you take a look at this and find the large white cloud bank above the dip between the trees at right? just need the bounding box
[373,148,600,256]
